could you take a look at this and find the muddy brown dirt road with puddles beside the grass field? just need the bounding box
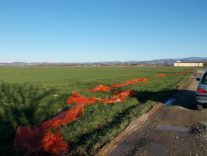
[99,77,207,156]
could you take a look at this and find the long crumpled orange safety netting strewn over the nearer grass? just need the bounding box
[14,78,148,155]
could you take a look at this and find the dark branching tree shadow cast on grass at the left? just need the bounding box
[0,83,66,155]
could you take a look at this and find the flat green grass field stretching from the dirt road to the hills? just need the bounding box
[0,67,195,155]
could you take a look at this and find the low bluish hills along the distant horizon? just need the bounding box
[0,57,207,66]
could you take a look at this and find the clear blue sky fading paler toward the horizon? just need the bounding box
[0,0,207,62]
